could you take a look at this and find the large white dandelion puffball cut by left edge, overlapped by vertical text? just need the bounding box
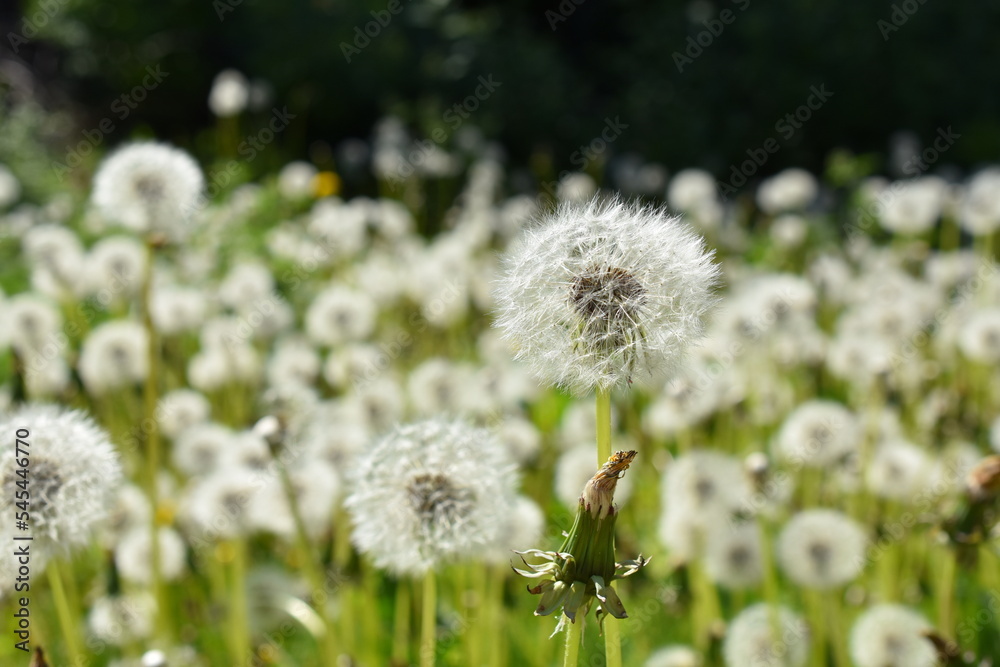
[0,405,122,553]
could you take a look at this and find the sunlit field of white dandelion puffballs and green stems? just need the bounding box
[0,26,1000,667]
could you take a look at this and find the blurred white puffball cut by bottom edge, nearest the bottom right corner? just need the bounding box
[850,604,938,667]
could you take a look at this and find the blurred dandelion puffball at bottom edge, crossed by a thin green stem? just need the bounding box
[722,602,809,667]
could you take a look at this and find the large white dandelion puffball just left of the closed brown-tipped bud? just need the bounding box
[345,420,515,575]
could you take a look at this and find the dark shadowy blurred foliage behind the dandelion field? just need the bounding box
[2,0,1000,196]
